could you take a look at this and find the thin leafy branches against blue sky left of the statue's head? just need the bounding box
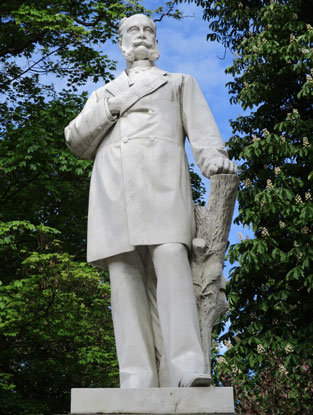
[0,0,143,99]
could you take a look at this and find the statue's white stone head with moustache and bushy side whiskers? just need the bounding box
[118,14,160,62]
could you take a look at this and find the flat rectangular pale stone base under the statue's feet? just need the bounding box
[71,387,235,415]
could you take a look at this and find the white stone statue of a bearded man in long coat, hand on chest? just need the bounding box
[65,14,236,388]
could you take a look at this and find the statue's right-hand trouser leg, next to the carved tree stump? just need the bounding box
[150,243,205,386]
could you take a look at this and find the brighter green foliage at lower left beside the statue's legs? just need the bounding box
[0,221,118,415]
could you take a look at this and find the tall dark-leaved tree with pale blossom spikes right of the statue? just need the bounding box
[178,0,313,414]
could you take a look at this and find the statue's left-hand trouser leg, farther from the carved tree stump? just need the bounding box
[108,251,159,388]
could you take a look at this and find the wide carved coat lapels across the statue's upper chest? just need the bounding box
[106,67,167,115]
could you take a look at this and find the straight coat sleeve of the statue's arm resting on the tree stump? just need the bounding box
[181,75,228,177]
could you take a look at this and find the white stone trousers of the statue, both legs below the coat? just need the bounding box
[107,243,204,388]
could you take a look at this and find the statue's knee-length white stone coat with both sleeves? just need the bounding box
[65,67,227,267]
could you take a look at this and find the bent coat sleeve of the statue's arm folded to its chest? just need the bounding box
[64,91,116,160]
